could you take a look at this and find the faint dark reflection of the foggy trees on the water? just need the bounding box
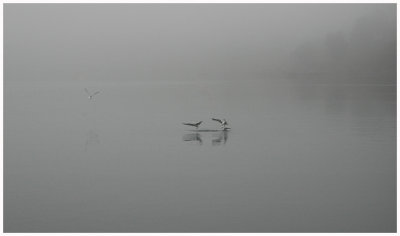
[293,84,396,140]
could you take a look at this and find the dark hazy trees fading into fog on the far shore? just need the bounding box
[280,12,396,84]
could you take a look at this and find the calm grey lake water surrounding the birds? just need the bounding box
[4,81,396,232]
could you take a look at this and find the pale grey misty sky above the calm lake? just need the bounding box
[4,4,396,84]
